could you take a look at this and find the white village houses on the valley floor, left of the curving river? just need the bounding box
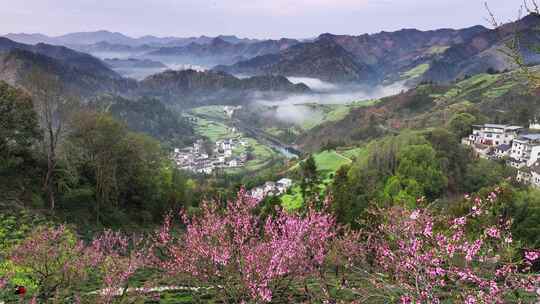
[172,138,249,174]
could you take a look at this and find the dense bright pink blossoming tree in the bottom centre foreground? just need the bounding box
[154,190,334,302]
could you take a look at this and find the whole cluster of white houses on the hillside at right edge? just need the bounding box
[462,120,540,188]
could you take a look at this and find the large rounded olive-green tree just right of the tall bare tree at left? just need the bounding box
[68,111,163,224]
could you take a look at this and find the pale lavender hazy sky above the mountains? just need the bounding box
[0,0,522,38]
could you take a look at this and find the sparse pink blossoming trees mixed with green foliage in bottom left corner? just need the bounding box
[6,226,146,303]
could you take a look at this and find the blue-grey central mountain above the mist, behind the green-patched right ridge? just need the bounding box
[216,26,488,82]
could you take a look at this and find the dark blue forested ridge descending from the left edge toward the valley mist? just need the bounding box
[0,38,309,107]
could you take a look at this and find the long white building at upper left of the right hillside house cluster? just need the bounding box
[465,124,523,147]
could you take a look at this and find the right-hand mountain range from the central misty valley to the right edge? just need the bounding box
[215,14,540,85]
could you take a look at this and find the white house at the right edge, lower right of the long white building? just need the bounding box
[509,134,540,168]
